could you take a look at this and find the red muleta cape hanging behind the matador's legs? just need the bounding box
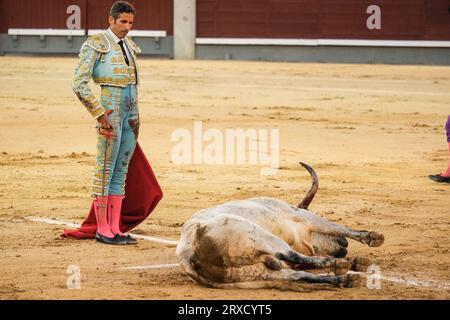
[62,143,163,239]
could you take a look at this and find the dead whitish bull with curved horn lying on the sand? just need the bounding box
[176,163,384,290]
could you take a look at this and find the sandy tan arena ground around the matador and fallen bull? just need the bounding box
[0,57,450,299]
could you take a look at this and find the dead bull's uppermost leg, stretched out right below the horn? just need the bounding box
[295,209,384,247]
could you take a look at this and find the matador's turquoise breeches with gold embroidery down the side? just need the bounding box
[92,85,139,197]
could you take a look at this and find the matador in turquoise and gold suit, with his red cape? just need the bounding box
[64,1,162,245]
